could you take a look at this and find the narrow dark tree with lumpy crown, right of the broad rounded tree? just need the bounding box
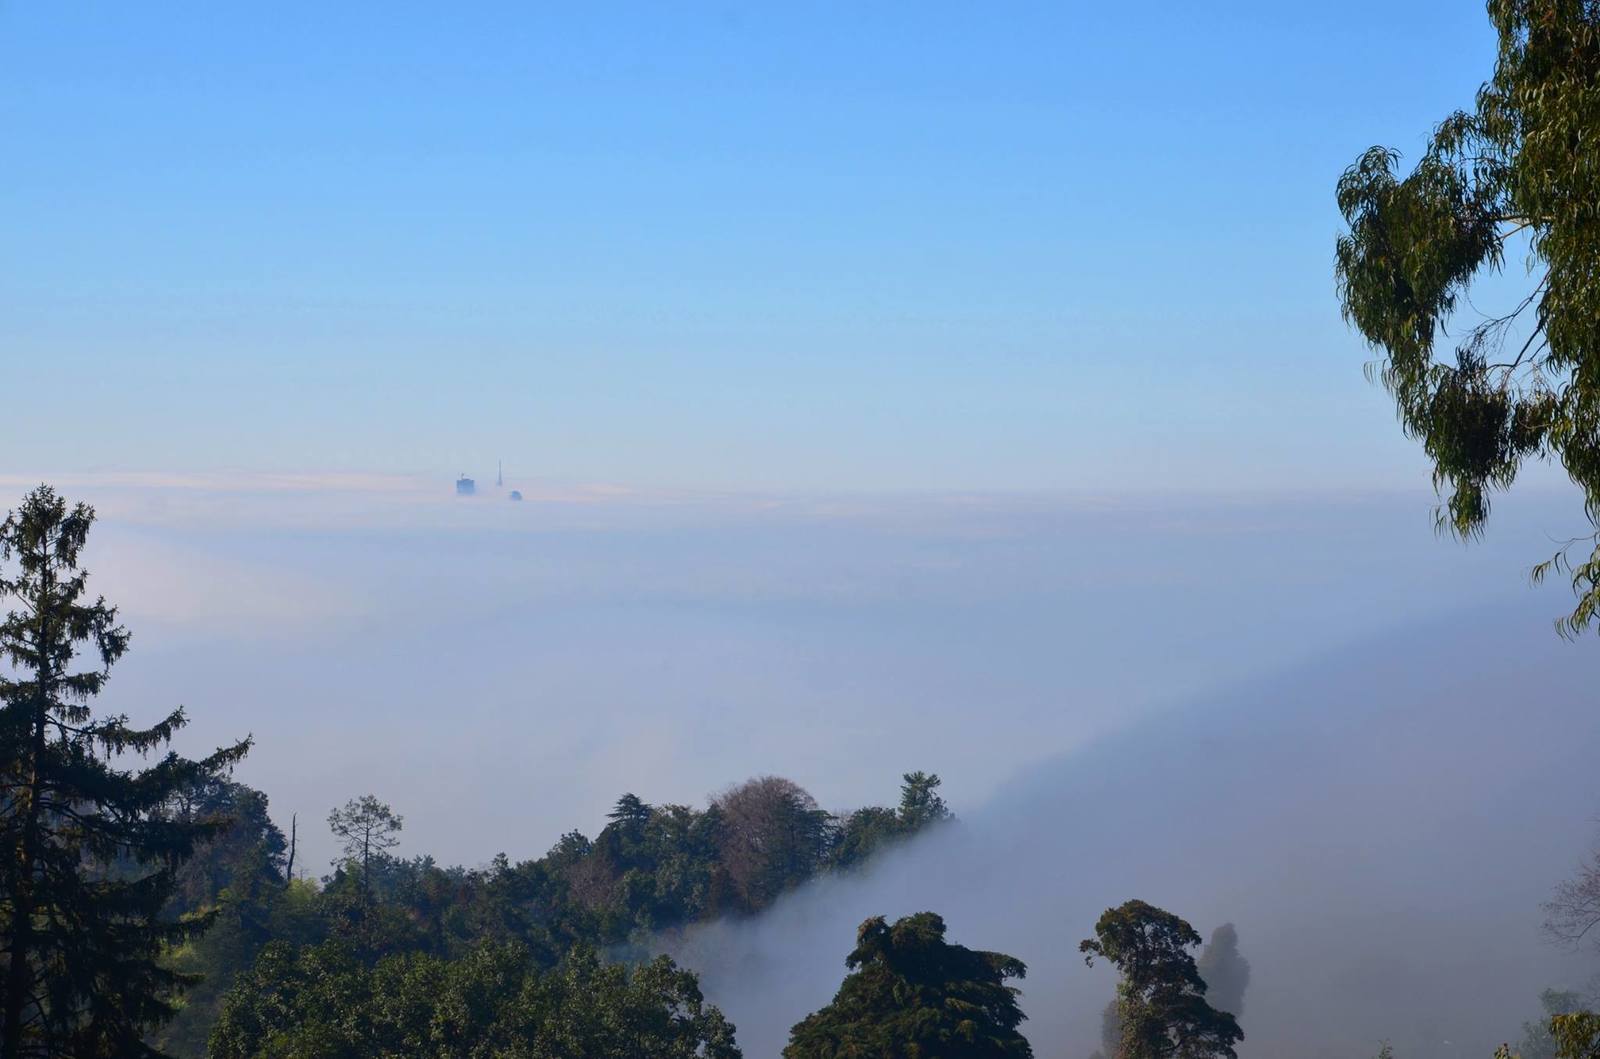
[1078,901,1245,1059]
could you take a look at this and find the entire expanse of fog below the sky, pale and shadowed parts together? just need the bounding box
[8,475,1600,1059]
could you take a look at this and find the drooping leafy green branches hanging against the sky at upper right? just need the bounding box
[1338,0,1600,632]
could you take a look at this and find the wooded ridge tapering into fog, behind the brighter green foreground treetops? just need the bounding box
[152,773,950,1057]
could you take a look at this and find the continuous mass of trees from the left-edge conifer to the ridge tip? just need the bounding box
[0,488,960,1059]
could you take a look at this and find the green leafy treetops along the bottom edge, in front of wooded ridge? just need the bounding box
[211,942,739,1059]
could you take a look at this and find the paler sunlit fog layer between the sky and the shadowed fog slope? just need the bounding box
[10,477,1581,889]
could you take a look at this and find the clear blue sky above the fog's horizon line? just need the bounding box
[0,0,1493,490]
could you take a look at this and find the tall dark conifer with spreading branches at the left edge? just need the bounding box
[0,486,250,1059]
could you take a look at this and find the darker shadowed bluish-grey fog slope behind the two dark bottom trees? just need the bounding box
[661,600,1600,1059]
